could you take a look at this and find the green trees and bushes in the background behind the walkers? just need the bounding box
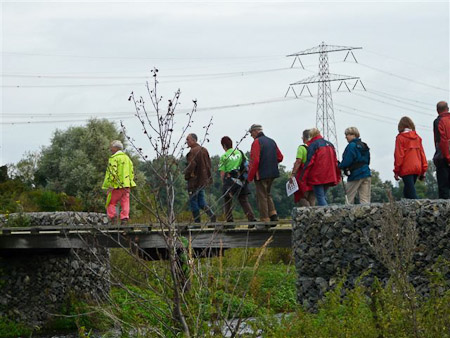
[0,119,437,220]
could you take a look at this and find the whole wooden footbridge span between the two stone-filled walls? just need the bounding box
[0,220,292,253]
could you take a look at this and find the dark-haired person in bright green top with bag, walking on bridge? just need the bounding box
[219,136,256,222]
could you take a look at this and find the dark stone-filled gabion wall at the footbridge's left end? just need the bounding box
[0,212,110,327]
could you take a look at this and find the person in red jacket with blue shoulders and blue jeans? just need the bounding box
[300,128,341,206]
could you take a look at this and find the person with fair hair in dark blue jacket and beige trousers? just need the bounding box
[339,127,371,204]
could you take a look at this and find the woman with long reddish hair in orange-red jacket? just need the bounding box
[394,116,428,199]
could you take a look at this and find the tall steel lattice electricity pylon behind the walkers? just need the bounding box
[285,42,365,150]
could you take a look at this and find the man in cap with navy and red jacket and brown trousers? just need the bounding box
[247,124,283,222]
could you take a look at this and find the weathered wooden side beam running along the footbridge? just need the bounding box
[0,225,292,251]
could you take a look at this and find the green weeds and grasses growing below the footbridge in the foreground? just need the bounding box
[0,249,450,338]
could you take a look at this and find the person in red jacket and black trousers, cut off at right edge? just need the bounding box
[433,101,450,199]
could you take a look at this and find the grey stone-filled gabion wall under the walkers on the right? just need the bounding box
[292,200,450,309]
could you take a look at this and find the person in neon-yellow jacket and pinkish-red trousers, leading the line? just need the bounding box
[102,140,136,225]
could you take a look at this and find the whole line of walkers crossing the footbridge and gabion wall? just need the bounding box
[103,101,450,224]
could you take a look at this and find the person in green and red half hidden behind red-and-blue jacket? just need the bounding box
[292,129,316,207]
